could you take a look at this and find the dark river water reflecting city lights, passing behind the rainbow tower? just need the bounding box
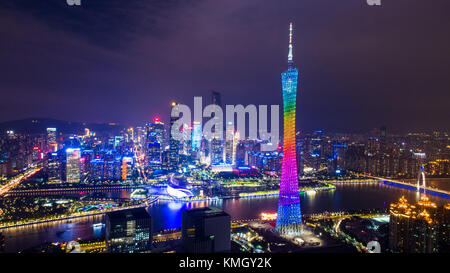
[0,183,449,252]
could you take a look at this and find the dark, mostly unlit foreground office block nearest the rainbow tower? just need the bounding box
[181,207,231,253]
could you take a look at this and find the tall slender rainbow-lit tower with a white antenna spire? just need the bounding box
[276,23,302,235]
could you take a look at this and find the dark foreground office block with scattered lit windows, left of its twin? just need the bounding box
[106,208,153,253]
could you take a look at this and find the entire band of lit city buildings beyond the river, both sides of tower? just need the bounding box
[0,110,450,183]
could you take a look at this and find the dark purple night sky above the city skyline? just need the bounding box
[0,0,450,132]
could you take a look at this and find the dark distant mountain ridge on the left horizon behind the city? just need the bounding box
[0,118,123,134]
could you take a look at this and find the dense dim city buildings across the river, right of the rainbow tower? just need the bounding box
[297,127,450,178]
